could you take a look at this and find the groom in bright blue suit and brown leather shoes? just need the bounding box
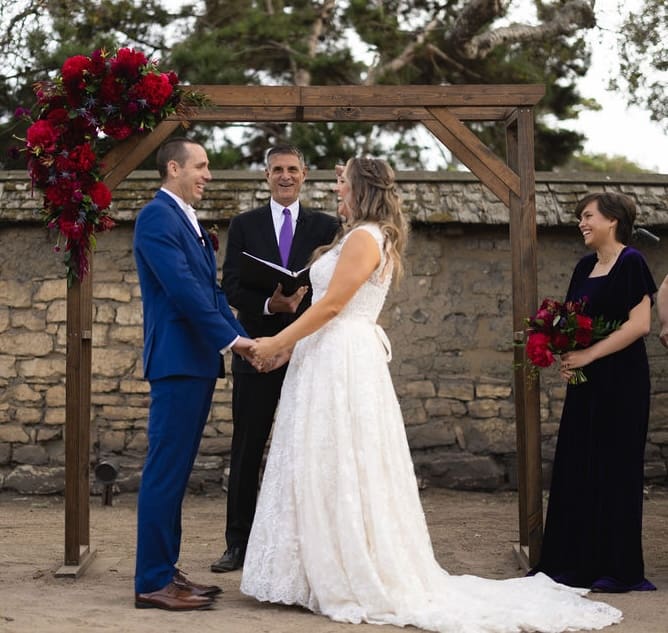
[134,138,252,611]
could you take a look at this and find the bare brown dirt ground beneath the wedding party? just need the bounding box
[0,489,668,633]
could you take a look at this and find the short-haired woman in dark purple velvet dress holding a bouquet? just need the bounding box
[533,193,656,592]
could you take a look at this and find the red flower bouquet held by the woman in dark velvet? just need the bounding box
[526,297,620,385]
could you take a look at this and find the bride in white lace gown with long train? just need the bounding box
[241,158,622,633]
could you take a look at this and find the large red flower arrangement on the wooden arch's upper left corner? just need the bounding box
[17,48,204,285]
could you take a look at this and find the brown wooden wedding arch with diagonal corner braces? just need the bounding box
[57,85,545,576]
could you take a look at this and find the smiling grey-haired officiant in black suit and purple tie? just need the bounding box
[211,145,339,572]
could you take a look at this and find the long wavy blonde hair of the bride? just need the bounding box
[313,158,408,282]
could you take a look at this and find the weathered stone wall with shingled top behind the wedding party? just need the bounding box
[0,172,668,494]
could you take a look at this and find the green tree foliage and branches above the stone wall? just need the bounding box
[0,0,666,169]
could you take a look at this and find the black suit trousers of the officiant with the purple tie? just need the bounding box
[225,365,287,550]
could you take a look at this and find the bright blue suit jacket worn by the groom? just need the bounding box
[134,191,247,380]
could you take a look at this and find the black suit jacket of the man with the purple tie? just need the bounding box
[222,204,339,372]
